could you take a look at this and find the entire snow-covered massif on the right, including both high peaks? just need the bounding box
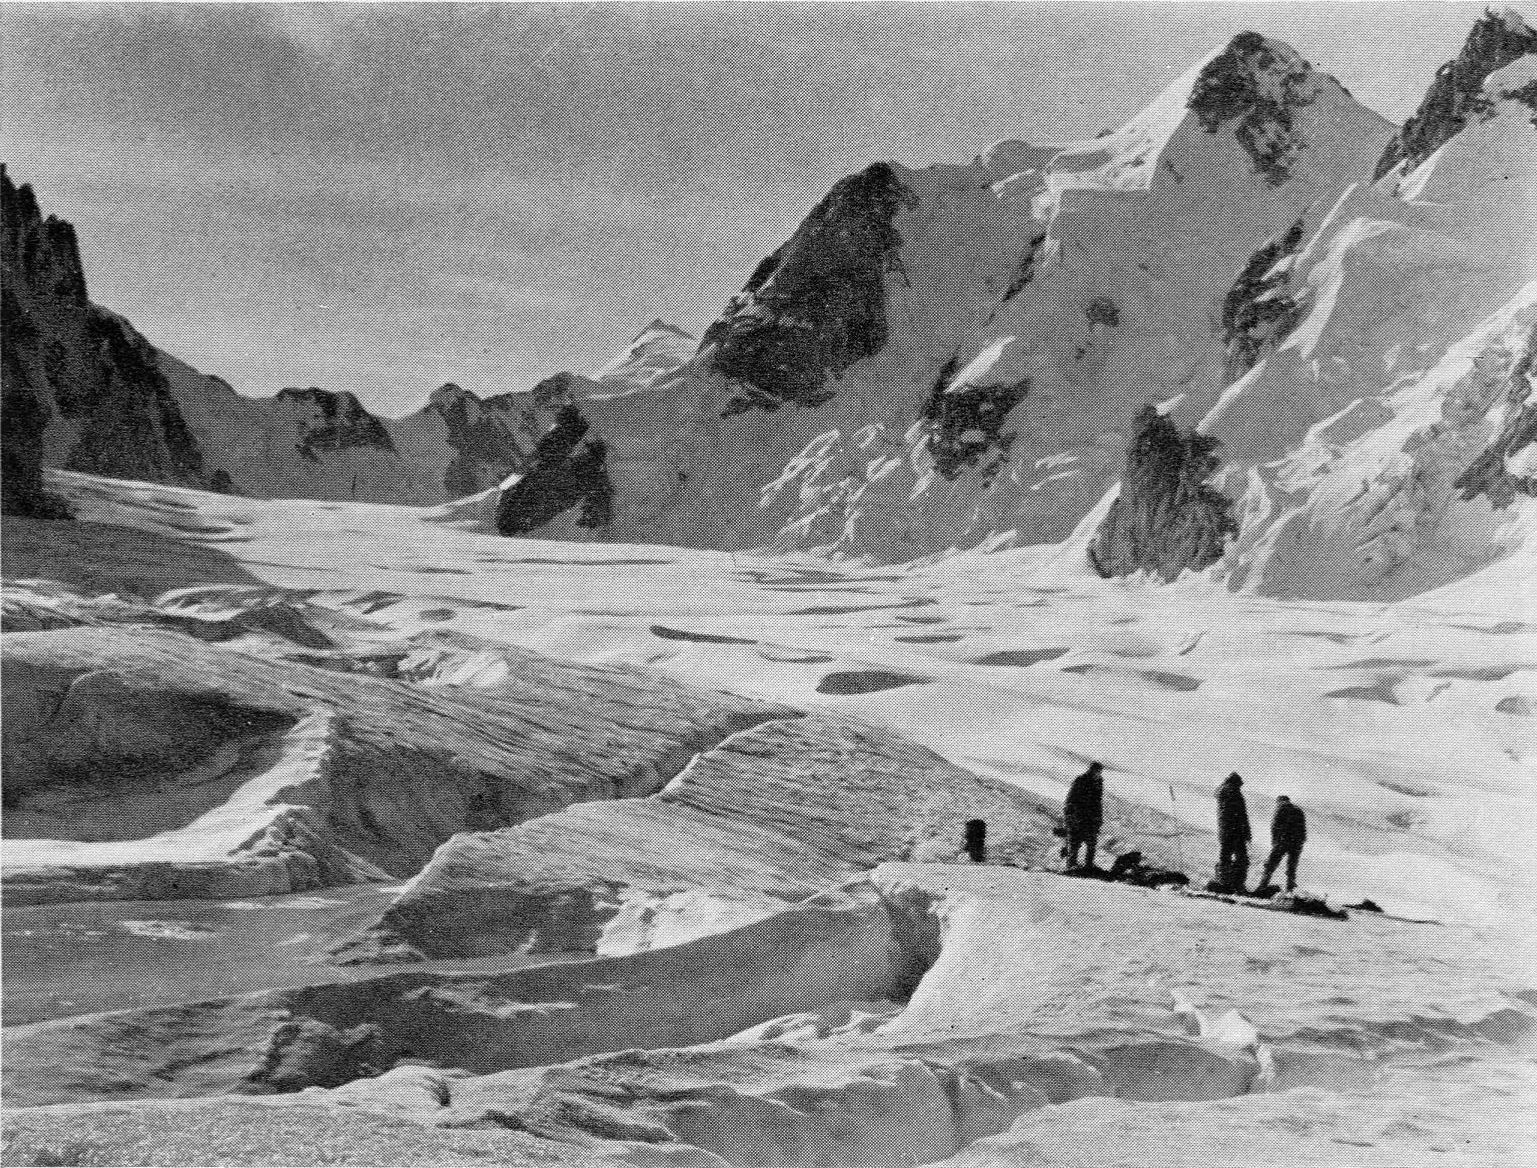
[501,11,1537,596]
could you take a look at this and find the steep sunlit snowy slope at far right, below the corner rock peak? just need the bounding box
[1200,14,1537,599]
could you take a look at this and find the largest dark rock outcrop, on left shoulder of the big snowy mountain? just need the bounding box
[699,163,913,415]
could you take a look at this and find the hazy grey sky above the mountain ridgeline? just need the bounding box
[0,3,1500,415]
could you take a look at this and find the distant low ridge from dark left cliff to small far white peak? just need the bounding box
[0,168,693,513]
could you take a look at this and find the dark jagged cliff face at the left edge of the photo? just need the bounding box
[0,168,203,513]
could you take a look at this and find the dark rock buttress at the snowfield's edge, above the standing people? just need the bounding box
[1088,406,1237,581]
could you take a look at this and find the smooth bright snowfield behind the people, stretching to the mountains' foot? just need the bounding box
[14,475,1537,916]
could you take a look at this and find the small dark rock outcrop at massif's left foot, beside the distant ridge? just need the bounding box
[496,406,613,535]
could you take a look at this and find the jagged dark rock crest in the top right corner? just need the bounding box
[1374,9,1537,178]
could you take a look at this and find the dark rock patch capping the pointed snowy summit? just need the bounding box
[1188,32,1310,186]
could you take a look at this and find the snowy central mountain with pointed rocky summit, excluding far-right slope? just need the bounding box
[501,34,1393,559]
